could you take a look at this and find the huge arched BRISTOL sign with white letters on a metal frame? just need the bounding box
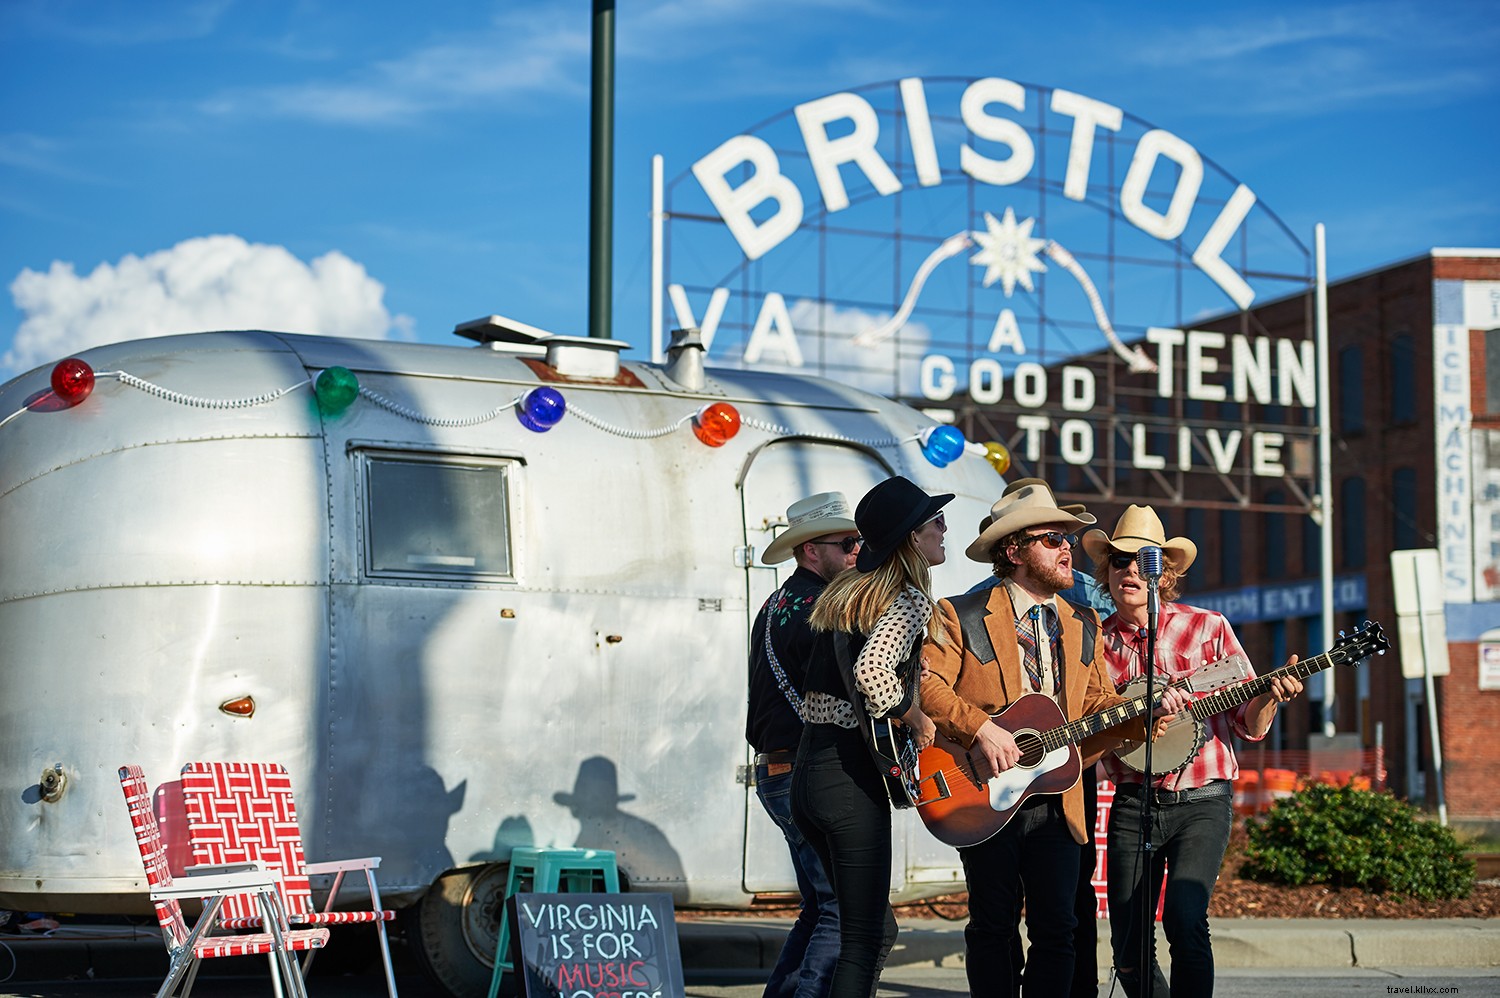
[666,77,1317,507]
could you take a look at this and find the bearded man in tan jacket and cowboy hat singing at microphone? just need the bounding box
[921,482,1184,998]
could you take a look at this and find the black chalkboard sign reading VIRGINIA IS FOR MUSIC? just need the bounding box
[507,894,687,998]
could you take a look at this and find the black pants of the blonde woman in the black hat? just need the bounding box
[792,725,897,998]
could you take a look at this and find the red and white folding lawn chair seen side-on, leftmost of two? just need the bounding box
[120,765,329,998]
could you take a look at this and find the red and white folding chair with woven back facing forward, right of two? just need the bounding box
[183,762,396,998]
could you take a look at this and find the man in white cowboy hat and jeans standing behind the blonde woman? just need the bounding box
[746,492,860,998]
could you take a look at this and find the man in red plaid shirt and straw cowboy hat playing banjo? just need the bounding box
[1083,506,1302,998]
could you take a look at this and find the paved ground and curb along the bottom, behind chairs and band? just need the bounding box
[0,917,1500,998]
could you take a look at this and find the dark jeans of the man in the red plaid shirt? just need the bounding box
[1109,792,1235,998]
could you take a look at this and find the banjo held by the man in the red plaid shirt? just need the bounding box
[1115,620,1391,776]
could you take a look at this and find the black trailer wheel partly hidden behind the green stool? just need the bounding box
[407,863,515,998]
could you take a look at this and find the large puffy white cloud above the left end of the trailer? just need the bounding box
[0,236,411,372]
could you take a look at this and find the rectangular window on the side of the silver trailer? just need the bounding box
[365,455,512,579]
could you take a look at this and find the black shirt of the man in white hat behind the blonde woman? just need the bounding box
[746,566,828,752]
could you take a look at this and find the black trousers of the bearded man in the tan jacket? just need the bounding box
[959,794,1082,998]
